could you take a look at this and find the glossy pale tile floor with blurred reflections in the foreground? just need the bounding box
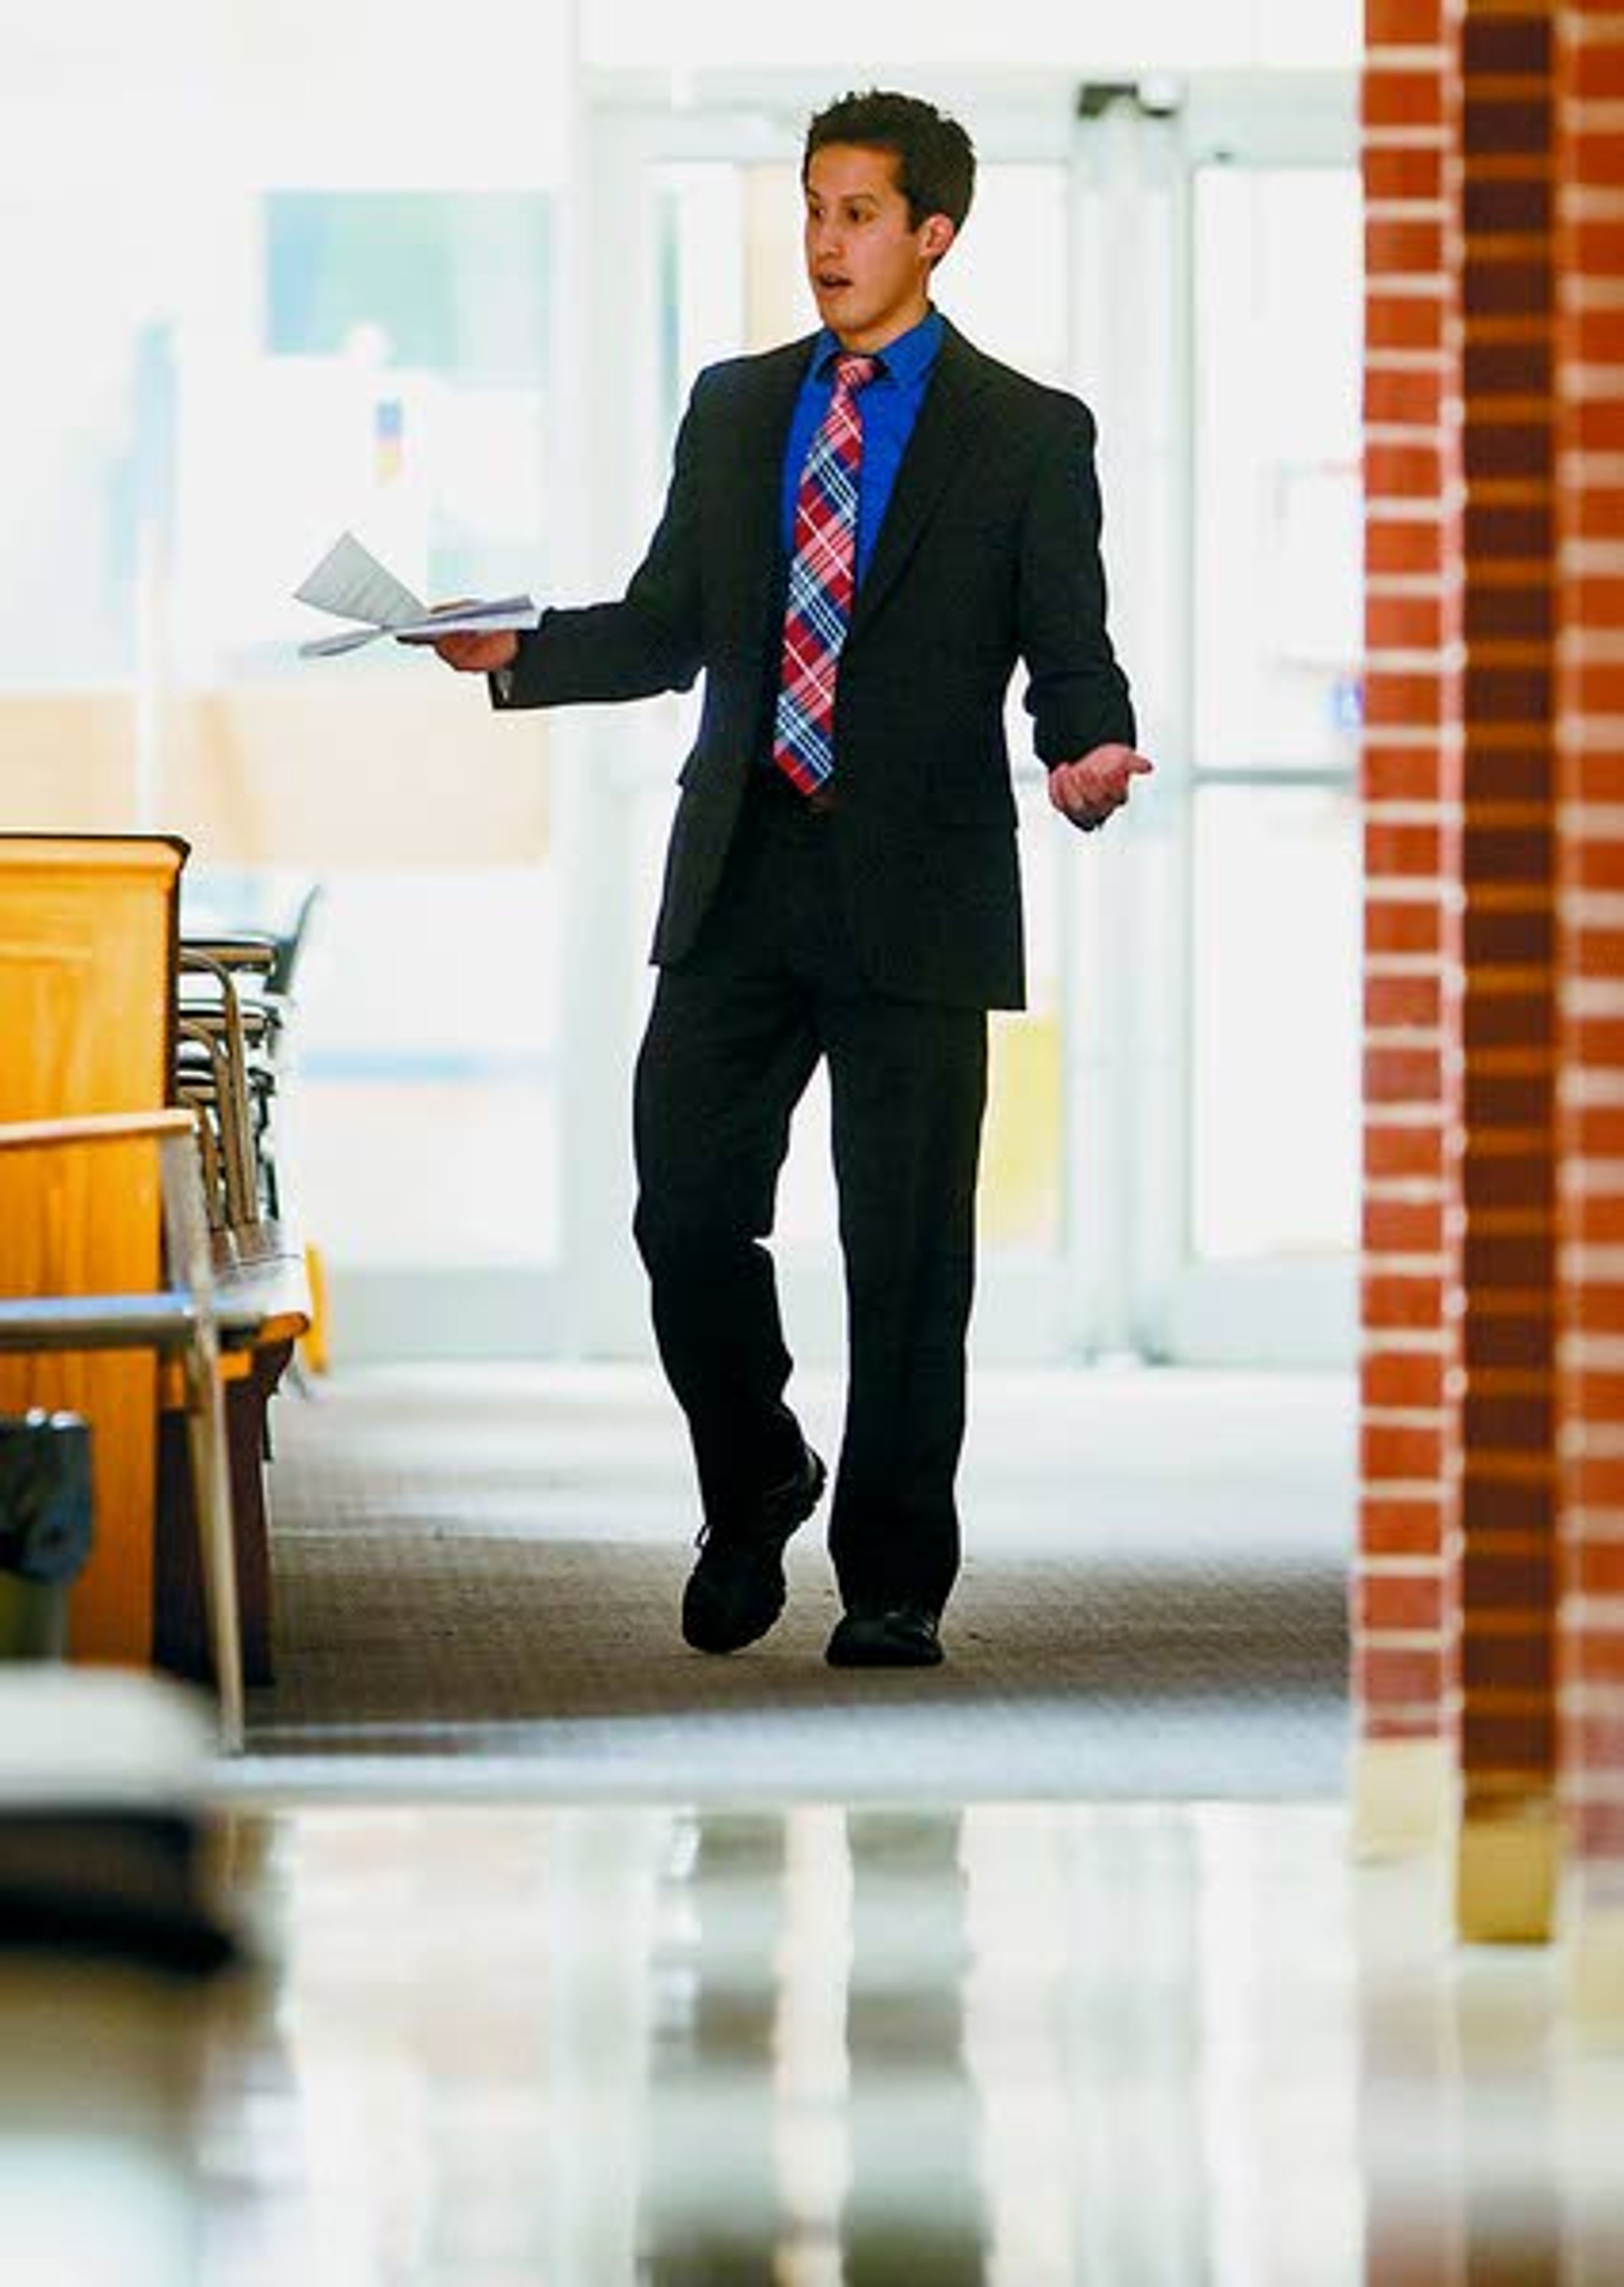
[0,1802,1624,2287]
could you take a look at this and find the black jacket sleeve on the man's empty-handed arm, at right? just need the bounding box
[1018,398,1137,764]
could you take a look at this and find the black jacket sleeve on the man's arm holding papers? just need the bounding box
[492,375,707,707]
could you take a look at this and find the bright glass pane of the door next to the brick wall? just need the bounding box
[1176,162,1361,1349]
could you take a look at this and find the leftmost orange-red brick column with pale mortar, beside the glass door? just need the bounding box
[1354,0,1455,1852]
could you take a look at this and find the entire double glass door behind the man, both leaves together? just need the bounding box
[558,67,1359,1363]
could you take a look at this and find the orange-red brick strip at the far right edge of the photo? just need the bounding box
[1555,13,1624,2024]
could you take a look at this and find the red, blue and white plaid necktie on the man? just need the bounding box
[773,357,878,794]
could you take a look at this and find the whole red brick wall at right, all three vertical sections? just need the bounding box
[1356,0,1624,1930]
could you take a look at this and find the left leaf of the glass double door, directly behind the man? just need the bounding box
[556,96,1102,1361]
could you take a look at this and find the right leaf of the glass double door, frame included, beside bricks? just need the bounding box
[1073,98,1361,1366]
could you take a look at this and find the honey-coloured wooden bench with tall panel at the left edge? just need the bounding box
[0,835,311,1719]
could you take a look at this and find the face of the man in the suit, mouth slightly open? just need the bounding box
[805,144,954,352]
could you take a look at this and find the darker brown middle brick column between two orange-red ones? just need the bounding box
[1446,0,1555,1939]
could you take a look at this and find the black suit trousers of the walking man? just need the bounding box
[634,771,986,1610]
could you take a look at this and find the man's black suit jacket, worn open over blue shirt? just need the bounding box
[505,325,1135,1009]
